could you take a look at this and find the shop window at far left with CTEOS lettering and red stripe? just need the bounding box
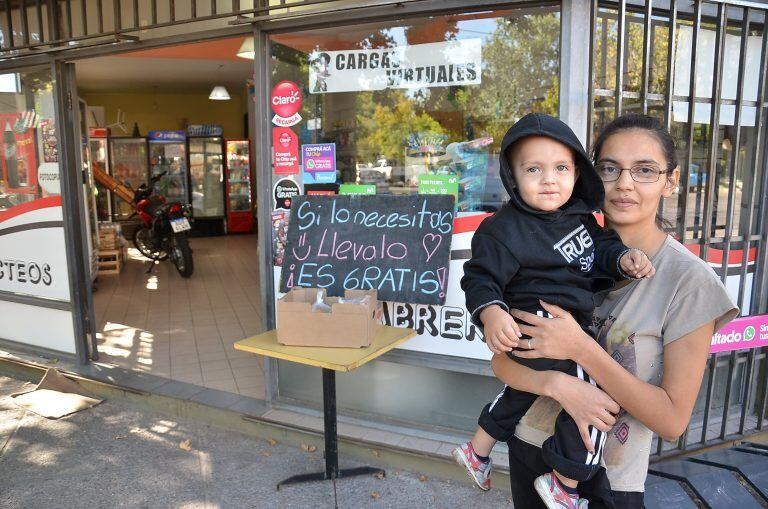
[0,69,75,353]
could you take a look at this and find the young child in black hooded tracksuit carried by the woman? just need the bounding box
[453,113,654,509]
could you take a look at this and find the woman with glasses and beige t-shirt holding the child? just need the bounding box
[492,115,738,509]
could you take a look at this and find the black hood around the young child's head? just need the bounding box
[499,113,605,214]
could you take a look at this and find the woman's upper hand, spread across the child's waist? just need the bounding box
[510,301,594,360]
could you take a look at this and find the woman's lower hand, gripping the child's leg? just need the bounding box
[551,373,620,453]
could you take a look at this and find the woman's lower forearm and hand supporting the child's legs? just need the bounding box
[491,354,619,451]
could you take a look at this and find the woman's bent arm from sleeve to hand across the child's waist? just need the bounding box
[512,304,715,441]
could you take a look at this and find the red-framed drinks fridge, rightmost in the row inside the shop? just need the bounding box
[226,140,253,233]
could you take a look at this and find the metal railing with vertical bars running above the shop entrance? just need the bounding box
[0,0,423,58]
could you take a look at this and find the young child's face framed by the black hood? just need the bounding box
[508,136,579,212]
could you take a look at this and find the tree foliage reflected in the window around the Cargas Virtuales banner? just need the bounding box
[356,12,560,161]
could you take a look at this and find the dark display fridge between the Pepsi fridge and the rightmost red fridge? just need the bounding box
[187,136,225,235]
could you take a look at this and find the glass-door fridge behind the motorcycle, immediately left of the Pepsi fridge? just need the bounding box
[109,138,149,221]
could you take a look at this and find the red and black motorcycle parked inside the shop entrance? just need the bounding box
[133,172,194,278]
